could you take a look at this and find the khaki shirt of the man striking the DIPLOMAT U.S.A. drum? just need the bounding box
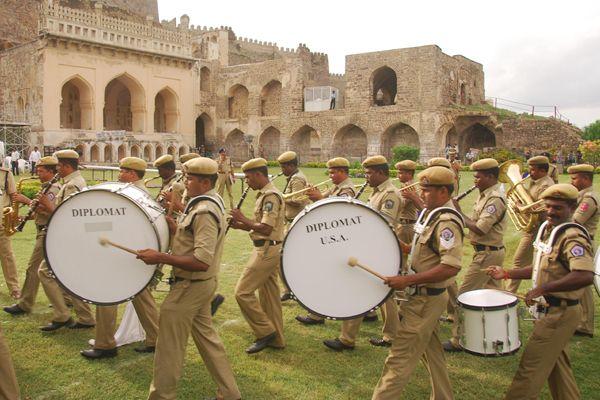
[411,201,464,288]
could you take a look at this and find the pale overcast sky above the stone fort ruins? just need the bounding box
[158,0,600,127]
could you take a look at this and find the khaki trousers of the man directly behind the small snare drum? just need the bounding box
[450,249,506,346]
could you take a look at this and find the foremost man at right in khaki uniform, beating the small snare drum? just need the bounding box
[489,184,594,400]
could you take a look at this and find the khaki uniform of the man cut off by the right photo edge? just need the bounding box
[573,186,600,335]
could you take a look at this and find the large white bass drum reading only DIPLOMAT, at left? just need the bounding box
[45,182,169,305]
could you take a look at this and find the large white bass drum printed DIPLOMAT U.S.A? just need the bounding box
[281,198,402,319]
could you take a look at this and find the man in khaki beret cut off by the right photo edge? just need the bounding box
[567,164,600,337]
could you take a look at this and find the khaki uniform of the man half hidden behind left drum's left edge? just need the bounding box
[38,171,95,325]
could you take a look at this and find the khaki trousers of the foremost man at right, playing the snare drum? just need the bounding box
[504,305,581,400]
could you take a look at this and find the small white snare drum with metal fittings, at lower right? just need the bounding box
[458,289,521,356]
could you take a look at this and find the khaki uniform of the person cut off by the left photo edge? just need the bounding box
[0,168,19,292]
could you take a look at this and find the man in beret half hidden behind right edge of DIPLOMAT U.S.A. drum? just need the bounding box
[323,155,402,351]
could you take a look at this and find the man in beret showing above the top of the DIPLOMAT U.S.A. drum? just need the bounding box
[296,157,356,325]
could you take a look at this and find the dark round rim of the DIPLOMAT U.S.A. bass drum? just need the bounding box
[279,196,402,321]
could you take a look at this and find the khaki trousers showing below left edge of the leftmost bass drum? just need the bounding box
[38,260,96,325]
